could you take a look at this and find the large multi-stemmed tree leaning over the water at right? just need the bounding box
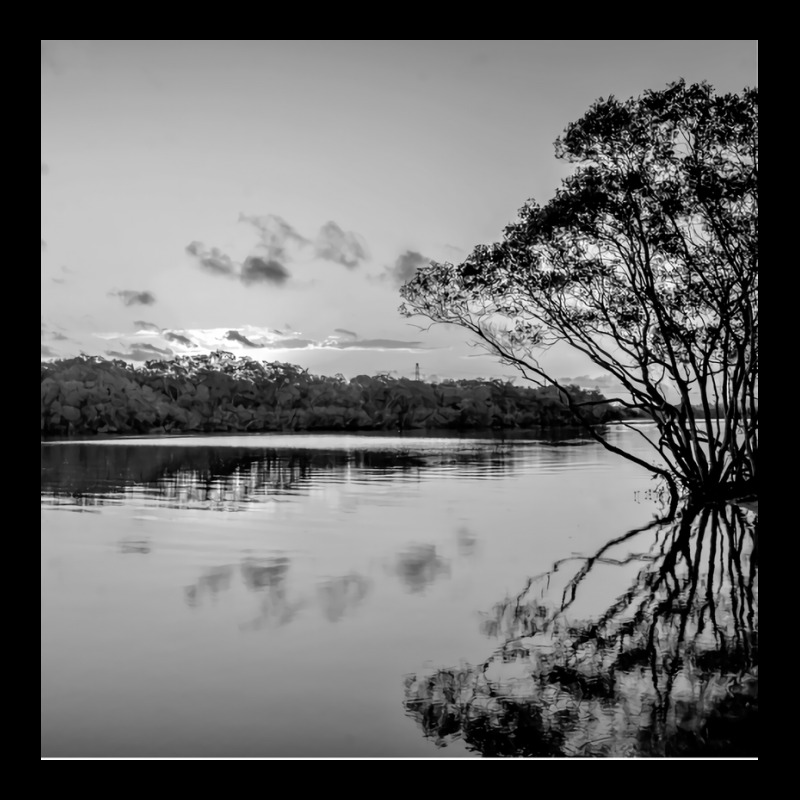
[400,80,758,496]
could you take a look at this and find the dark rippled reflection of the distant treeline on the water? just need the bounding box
[41,442,520,511]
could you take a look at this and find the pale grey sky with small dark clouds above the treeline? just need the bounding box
[41,40,758,379]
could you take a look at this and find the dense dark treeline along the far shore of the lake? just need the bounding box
[41,352,630,436]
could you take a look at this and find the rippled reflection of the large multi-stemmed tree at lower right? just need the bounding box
[404,505,758,757]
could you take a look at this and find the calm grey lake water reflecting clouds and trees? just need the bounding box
[41,428,757,758]
